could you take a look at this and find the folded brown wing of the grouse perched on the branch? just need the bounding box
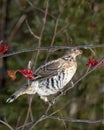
[34,60,62,78]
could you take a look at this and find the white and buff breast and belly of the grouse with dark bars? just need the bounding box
[37,63,76,95]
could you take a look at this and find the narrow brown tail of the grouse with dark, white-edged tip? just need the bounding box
[6,84,28,103]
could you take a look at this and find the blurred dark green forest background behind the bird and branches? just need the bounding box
[0,0,104,130]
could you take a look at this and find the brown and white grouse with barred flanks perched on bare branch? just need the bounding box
[6,48,82,103]
